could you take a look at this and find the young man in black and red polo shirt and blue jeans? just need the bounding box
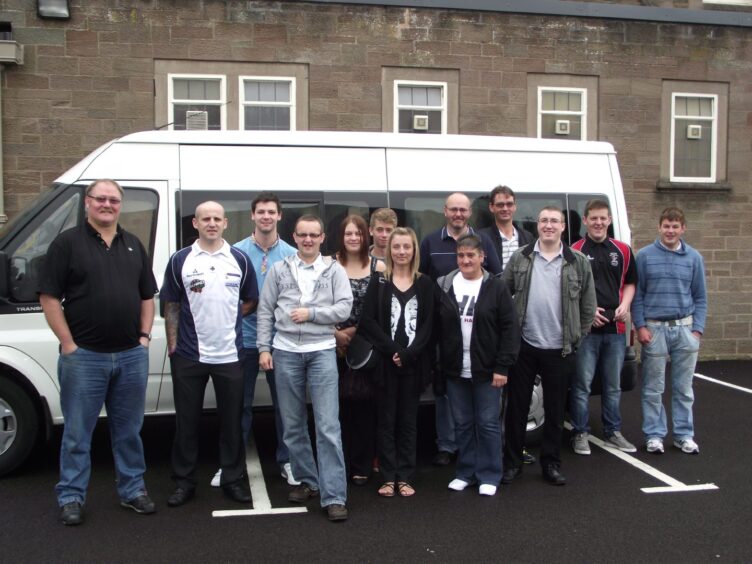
[569,199,637,455]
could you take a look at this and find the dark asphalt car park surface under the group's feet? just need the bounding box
[0,361,752,563]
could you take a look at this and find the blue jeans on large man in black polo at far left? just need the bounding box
[55,345,149,507]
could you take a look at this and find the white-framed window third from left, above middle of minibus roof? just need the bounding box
[394,80,447,133]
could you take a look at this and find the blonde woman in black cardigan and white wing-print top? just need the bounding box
[359,227,436,497]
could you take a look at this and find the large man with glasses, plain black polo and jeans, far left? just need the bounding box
[39,180,157,525]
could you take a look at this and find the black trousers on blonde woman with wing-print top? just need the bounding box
[377,370,420,482]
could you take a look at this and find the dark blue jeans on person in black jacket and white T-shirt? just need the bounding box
[447,378,502,486]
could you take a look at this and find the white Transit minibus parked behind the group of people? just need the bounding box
[0,131,636,475]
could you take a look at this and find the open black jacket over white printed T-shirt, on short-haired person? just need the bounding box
[436,270,520,381]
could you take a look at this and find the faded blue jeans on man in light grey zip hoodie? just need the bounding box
[273,349,347,507]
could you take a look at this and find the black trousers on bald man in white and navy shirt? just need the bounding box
[170,354,246,489]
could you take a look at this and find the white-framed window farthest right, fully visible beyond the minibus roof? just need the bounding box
[670,92,718,182]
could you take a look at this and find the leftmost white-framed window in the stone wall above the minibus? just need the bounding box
[168,74,226,130]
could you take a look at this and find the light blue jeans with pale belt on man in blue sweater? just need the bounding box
[642,323,700,440]
